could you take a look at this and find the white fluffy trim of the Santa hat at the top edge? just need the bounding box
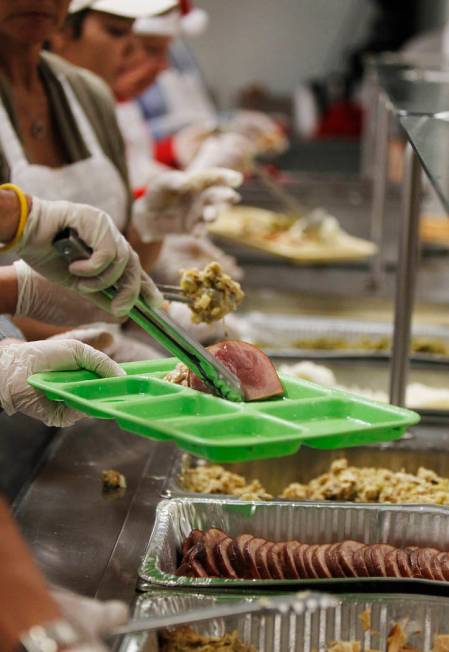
[134,0,209,37]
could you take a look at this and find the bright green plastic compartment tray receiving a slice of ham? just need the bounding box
[28,358,419,462]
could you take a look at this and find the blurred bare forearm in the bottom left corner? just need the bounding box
[0,499,61,652]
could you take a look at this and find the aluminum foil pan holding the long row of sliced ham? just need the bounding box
[139,498,449,592]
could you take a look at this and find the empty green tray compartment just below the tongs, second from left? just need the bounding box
[112,392,239,422]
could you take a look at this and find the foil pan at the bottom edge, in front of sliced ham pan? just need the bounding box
[120,591,449,652]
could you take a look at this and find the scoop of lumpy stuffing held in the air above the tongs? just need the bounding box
[180,262,245,324]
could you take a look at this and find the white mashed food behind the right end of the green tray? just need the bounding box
[279,360,449,410]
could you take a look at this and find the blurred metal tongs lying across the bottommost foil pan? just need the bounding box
[110,591,338,636]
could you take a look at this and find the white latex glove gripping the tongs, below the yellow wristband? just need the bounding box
[17,197,163,316]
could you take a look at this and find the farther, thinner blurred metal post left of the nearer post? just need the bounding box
[370,92,391,288]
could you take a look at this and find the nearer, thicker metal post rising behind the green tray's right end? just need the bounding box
[390,143,421,405]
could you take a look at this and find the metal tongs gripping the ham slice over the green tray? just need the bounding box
[53,229,245,401]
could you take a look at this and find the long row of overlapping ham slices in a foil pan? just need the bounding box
[176,528,449,582]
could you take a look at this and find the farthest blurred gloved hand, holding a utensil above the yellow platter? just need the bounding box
[226,111,288,154]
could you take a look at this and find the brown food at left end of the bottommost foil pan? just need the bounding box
[159,627,257,652]
